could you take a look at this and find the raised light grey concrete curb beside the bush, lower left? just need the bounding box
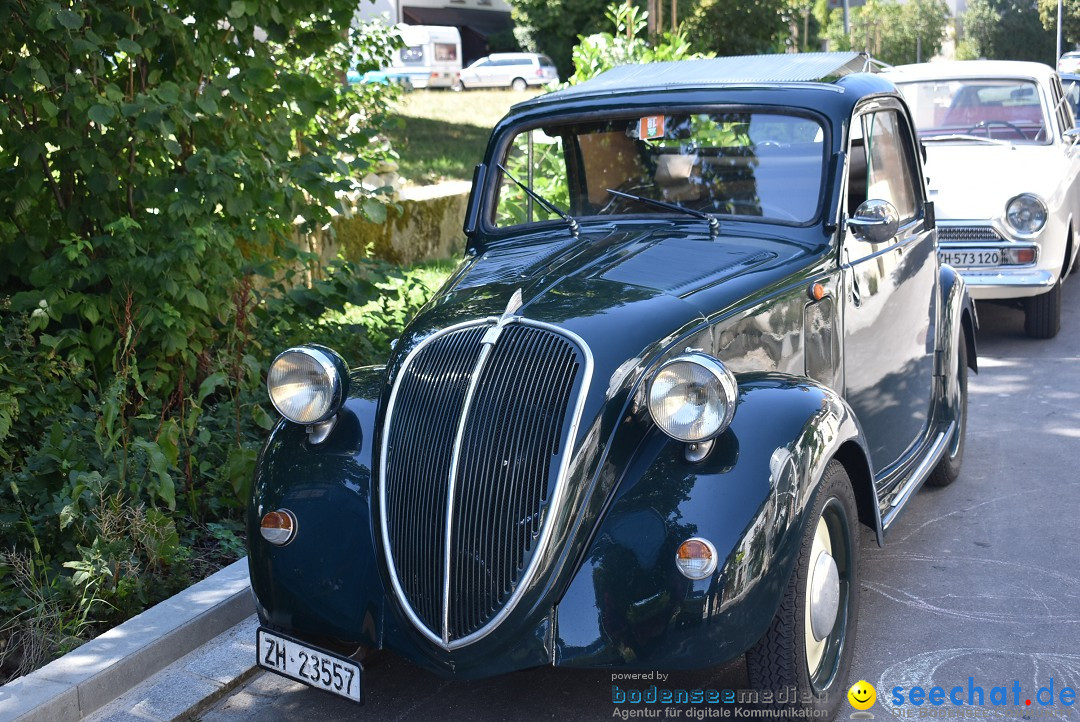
[0,558,255,722]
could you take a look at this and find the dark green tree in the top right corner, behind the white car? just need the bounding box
[957,0,1057,63]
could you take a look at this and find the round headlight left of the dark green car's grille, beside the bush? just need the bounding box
[267,346,346,424]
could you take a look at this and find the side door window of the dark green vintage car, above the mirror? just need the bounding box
[848,110,919,224]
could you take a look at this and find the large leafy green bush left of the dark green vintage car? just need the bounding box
[0,0,414,680]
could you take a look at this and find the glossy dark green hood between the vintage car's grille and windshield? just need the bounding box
[397,222,814,371]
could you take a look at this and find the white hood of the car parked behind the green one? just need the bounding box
[926,141,1068,220]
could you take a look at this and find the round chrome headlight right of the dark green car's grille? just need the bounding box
[649,353,739,441]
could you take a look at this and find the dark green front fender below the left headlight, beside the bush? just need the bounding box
[247,366,388,652]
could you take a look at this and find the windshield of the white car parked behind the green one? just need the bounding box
[897,78,1050,144]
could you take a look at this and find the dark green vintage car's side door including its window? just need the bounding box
[841,98,939,479]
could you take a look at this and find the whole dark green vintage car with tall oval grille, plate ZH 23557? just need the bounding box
[248,54,976,711]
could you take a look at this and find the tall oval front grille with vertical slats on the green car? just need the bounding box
[381,321,588,649]
